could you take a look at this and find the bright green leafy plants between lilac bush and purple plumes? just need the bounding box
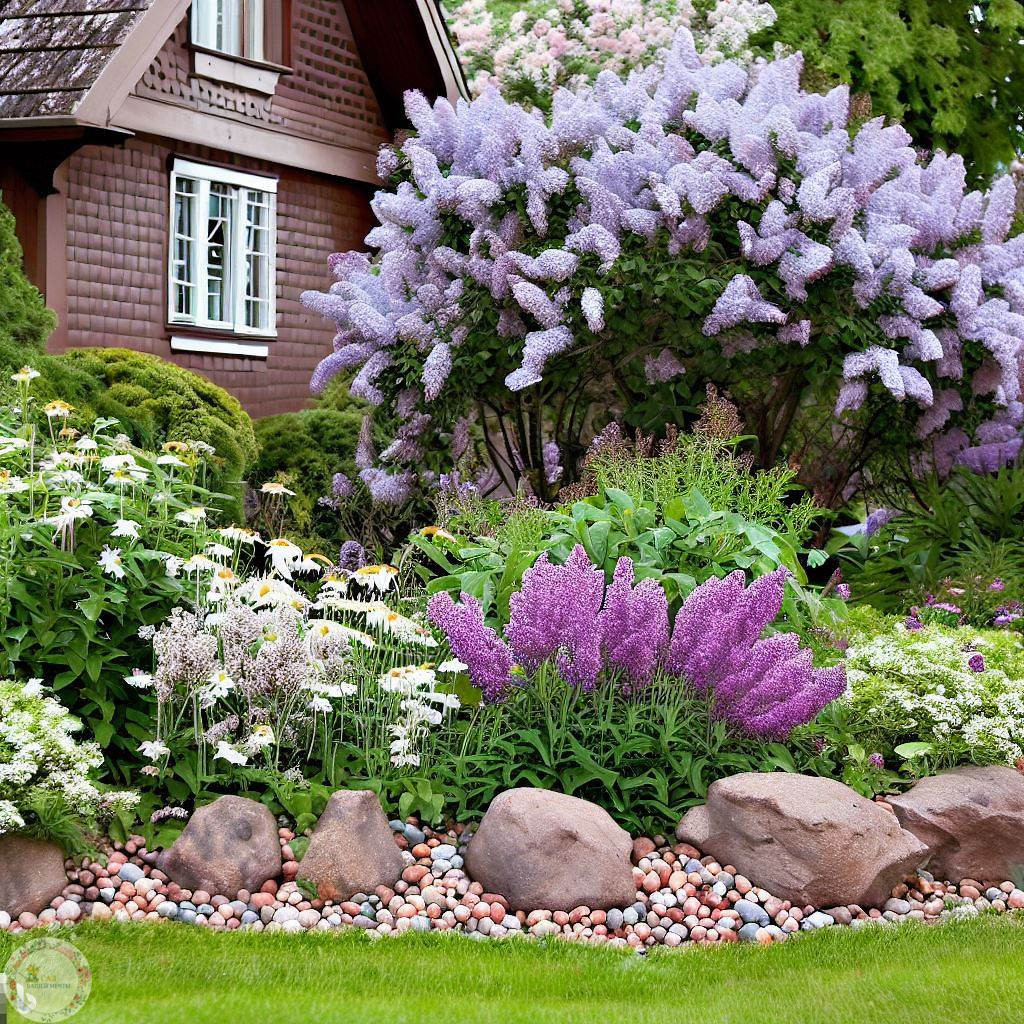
[413,413,827,626]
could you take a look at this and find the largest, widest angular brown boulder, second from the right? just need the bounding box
[676,772,928,906]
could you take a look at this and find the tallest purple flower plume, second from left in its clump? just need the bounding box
[505,544,604,689]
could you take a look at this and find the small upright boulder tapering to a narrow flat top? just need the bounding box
[298,790,404,900]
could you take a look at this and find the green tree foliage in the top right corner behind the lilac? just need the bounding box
[758,0,1024,175]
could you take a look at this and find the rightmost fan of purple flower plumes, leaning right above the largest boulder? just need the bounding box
[667,569,846,738]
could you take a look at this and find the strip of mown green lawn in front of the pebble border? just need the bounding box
[0,916,1024,1024]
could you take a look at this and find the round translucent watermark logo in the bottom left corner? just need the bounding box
[0,938,92,1024]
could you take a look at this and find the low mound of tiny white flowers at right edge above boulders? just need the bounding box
[845,624,1024,766]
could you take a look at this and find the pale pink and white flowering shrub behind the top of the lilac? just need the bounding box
[452,0,775,106]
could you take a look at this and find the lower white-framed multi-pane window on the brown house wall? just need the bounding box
[167,160,278,337]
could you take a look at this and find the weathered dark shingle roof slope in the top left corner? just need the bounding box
[0,0,155,119]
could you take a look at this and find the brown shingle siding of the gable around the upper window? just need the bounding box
[134,0,388,152]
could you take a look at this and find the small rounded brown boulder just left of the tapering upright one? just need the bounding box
[160,797,281,896]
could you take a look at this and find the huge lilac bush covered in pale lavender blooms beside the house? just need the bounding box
[303,30,1024,506]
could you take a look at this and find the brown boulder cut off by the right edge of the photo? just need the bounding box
[889,765,1024,885]
